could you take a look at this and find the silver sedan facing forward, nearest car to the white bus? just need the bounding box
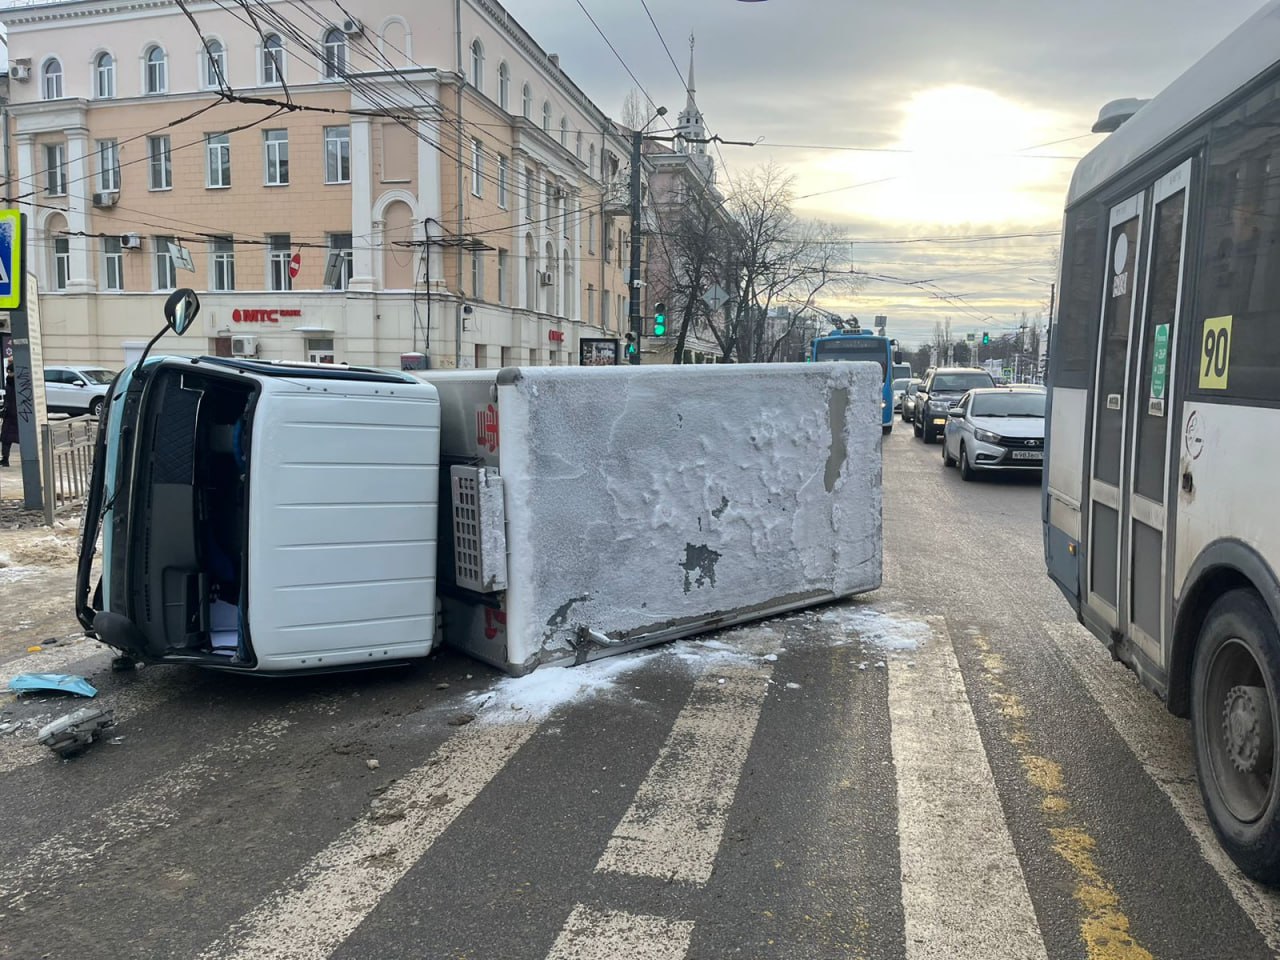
[942,387,1046,480]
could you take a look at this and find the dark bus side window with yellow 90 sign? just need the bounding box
[1188,84,1280,401]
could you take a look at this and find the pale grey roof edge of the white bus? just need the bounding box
[1066,0,1280,206]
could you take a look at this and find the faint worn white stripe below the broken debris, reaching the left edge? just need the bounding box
[0,719,292,909]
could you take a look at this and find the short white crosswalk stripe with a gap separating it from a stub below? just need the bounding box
[595,663,772,883]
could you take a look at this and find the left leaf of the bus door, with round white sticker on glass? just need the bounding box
[1088,193,1146,630]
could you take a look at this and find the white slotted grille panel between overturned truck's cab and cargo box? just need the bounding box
[449,466,507,594]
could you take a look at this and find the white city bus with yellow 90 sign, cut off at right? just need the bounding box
[1043,1,1280,884]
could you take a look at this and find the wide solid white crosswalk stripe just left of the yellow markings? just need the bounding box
[888,618,1046,960]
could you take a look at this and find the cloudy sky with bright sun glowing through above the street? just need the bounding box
[503,0,1262,344]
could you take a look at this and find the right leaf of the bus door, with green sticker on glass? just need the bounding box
[1125,160,1192,666]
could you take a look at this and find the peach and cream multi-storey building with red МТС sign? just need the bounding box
[0,0,630,367]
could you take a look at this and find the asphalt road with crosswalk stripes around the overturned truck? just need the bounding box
[0,425,1280,960]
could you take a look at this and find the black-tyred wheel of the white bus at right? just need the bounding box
[1192,590,1280,886]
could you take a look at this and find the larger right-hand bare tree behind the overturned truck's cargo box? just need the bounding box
[708,164,854,364]
